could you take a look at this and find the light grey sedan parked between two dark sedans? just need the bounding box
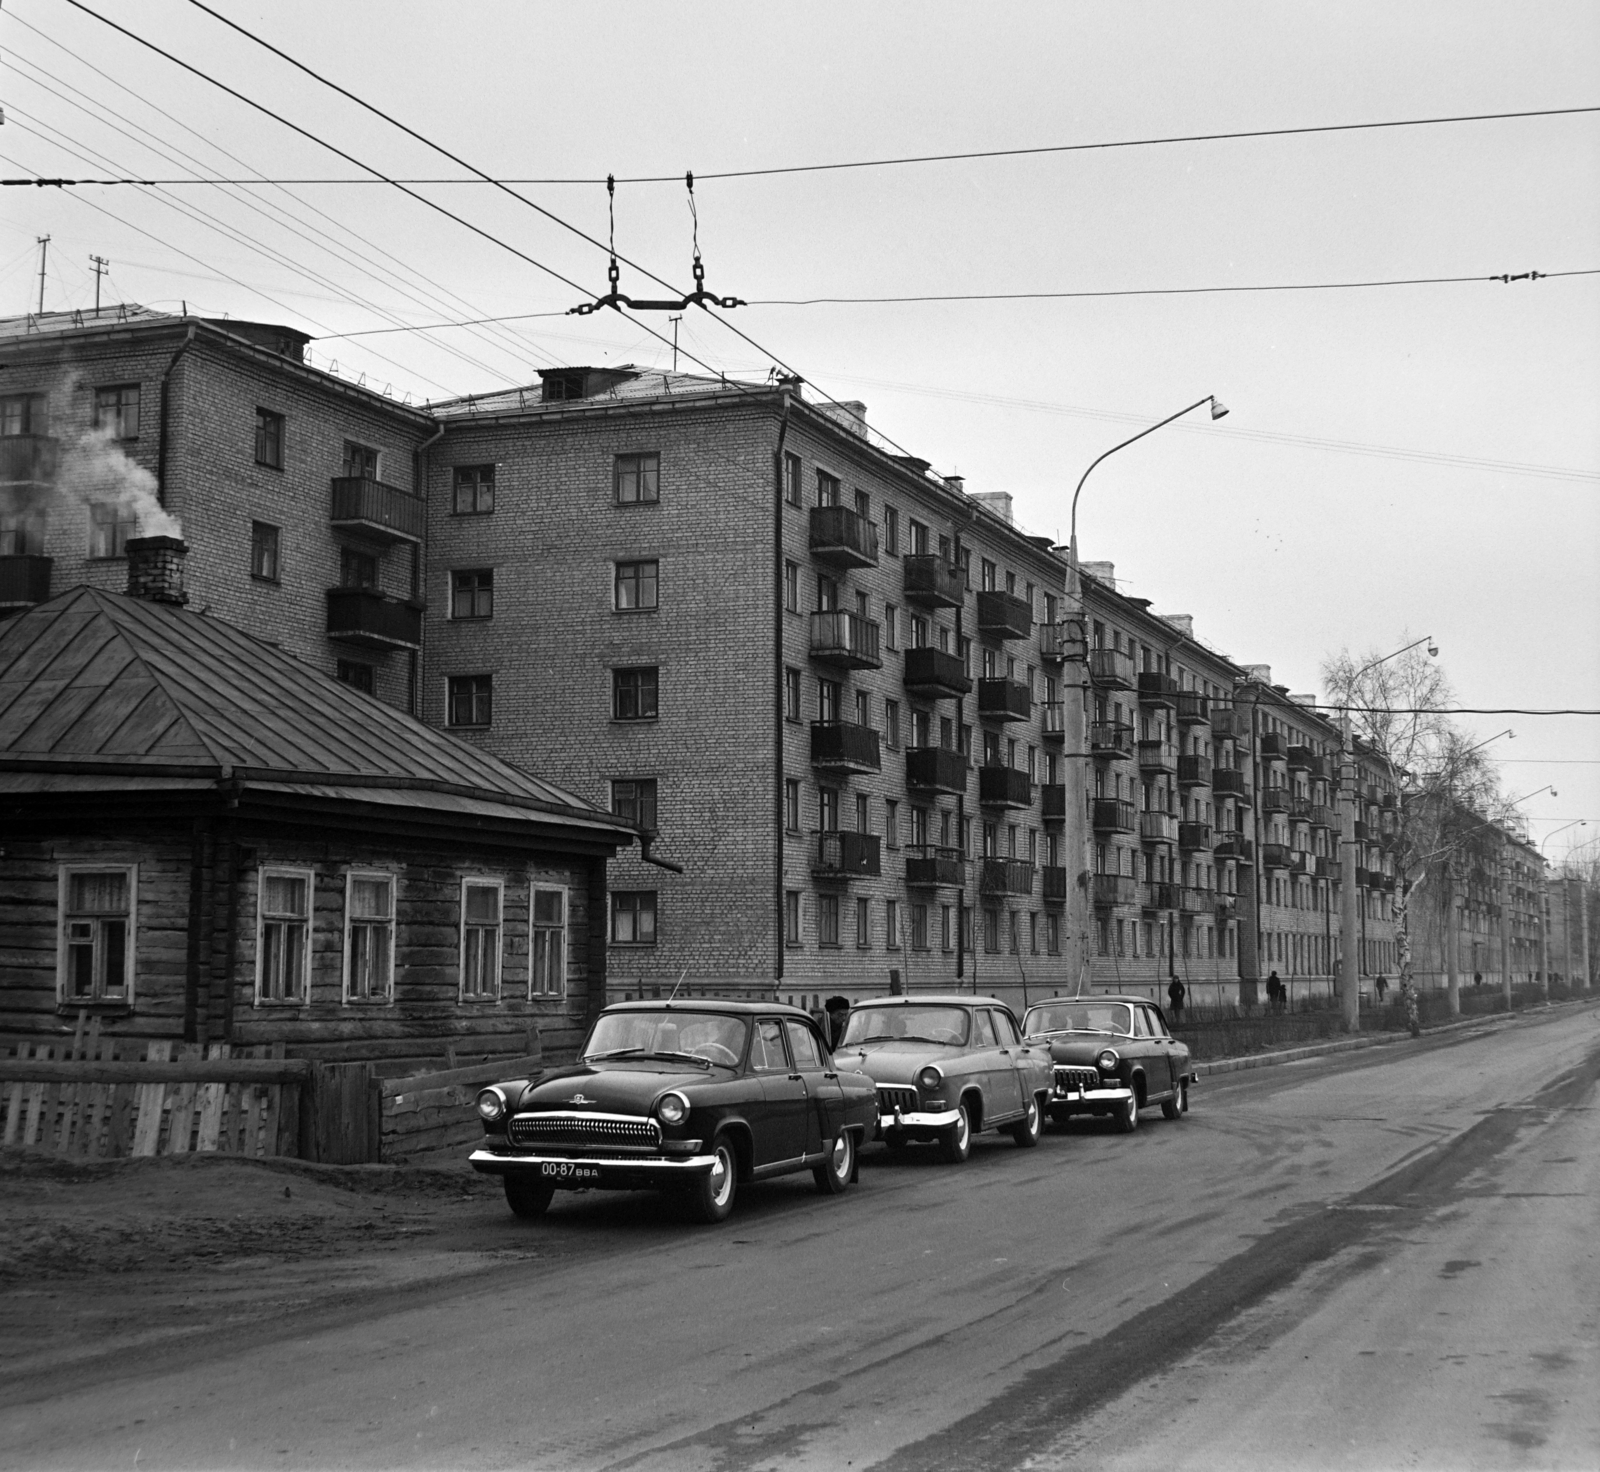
[837,995,1051,1163]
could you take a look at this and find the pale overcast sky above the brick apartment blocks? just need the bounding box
[0,0,1600,858]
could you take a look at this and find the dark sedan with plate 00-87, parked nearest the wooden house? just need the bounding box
[472,997,878,1222]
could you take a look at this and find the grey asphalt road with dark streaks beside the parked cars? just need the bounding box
[0,1006,1600,1472]
